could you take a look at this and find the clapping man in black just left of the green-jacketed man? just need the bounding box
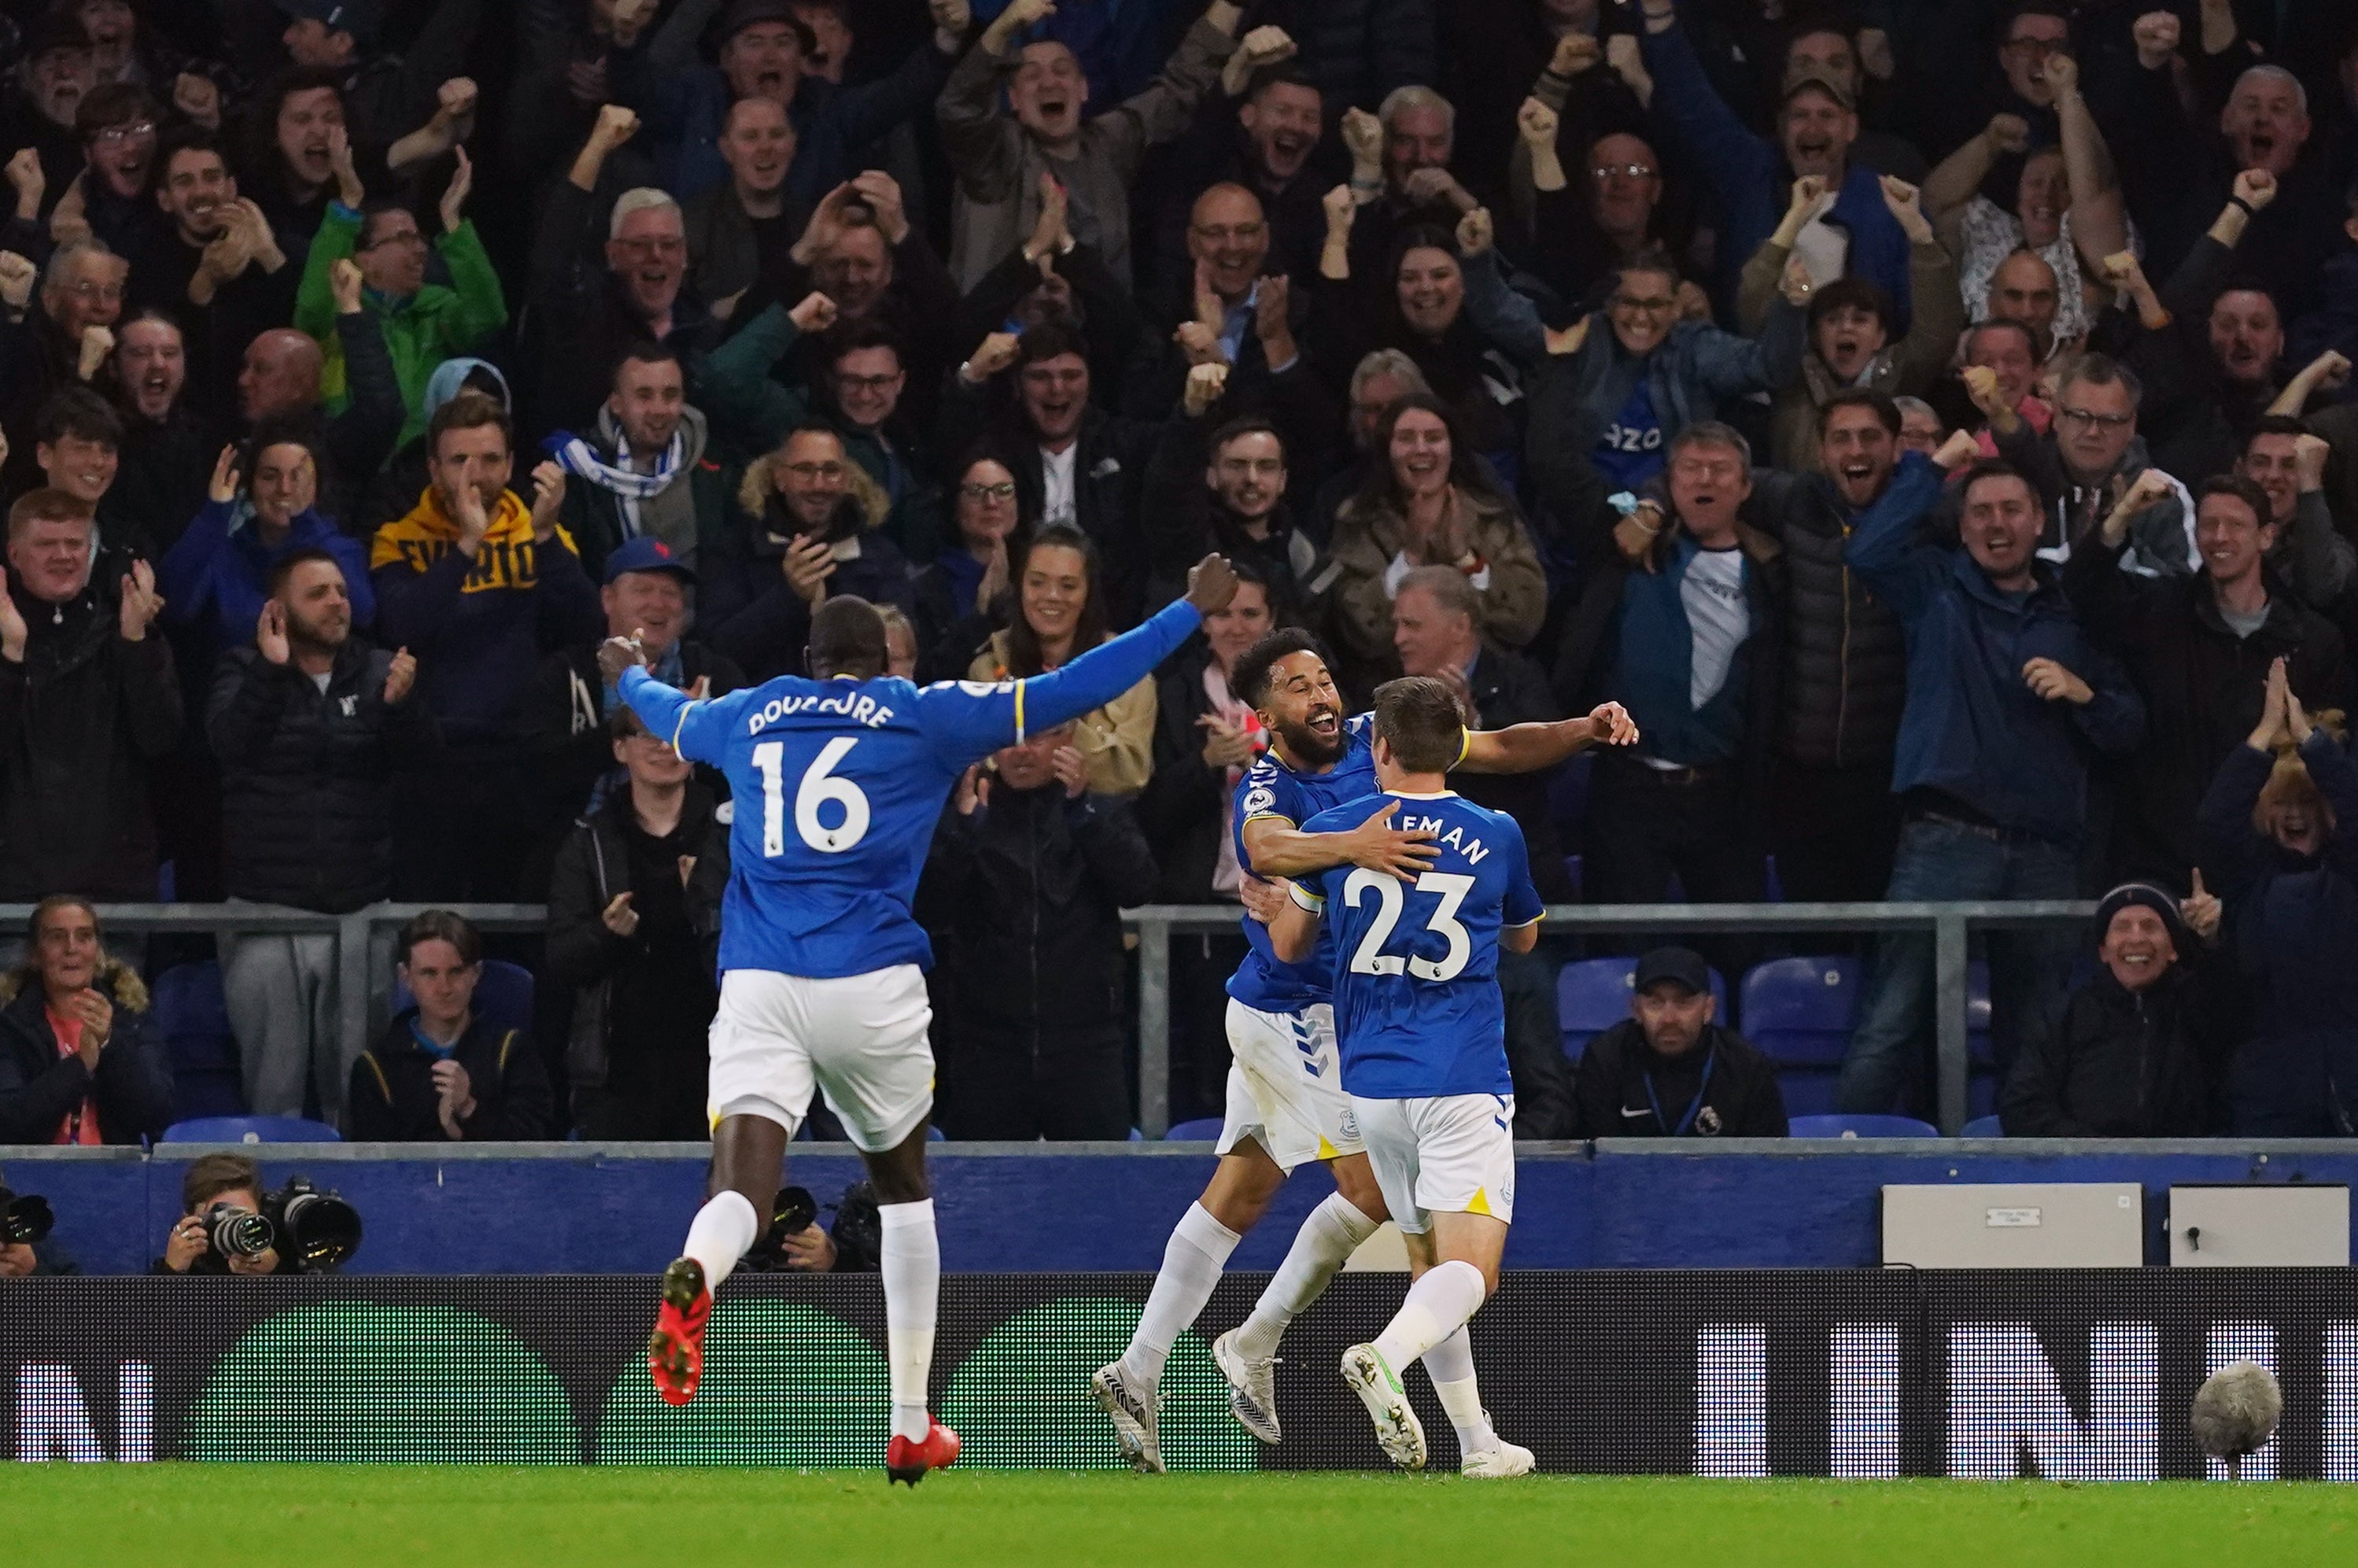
[125,127,302,419]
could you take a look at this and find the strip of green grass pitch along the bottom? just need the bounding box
[0,1464,2358,1568]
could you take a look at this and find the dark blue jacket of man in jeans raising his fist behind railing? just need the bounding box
[1844,452,2146,847]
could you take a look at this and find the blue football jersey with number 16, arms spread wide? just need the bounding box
[620,599,1200,979]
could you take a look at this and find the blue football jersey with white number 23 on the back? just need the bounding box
[1294,795,1544,1099]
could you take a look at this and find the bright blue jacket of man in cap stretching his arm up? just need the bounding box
[1641,13,1910,325]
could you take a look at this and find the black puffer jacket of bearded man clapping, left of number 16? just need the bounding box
[208,641,441,915]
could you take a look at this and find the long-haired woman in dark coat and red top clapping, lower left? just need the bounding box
[0,894,172,1146]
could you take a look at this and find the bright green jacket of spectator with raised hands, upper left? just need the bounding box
[295,201,507,450]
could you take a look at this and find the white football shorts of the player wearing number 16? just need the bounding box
[707,965,934,1153]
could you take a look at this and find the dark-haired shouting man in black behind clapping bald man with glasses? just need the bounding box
[1153,57,1325,288]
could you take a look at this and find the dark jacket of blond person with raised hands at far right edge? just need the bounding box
[2197,729,2358,1139]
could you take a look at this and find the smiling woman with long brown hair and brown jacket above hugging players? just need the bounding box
[1332,393,1547,688]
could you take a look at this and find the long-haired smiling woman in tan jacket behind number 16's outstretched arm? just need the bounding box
[967,523,1156,795]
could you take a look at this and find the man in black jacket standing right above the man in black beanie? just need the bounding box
[2063,474,2349,887]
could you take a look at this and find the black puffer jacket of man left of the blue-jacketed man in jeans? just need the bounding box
[1745,469,1908,769]
